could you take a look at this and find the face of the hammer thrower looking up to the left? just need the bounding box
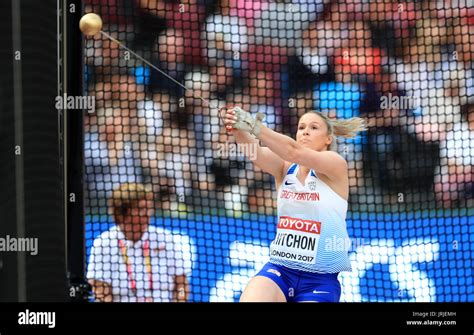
[296,113,332,151]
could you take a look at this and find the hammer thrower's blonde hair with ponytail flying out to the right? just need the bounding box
[306,111,367,151]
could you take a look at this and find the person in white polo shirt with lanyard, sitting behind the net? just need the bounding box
[87,183,191,302]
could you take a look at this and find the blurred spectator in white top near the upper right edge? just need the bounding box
[390,14,473,116]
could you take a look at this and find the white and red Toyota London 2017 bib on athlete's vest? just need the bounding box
[270,216,321,264]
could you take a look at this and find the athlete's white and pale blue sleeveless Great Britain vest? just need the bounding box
[270,164,352,273]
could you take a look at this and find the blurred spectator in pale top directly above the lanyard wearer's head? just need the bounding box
[85,74,163,213]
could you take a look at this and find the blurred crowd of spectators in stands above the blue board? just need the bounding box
[85,0,474,214]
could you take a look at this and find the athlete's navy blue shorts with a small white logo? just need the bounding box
[257,263,341,302]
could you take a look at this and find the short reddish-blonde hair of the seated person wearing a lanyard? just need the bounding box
[109,183,153,218]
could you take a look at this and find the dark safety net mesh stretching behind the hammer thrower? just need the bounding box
[84,0,474,302]
